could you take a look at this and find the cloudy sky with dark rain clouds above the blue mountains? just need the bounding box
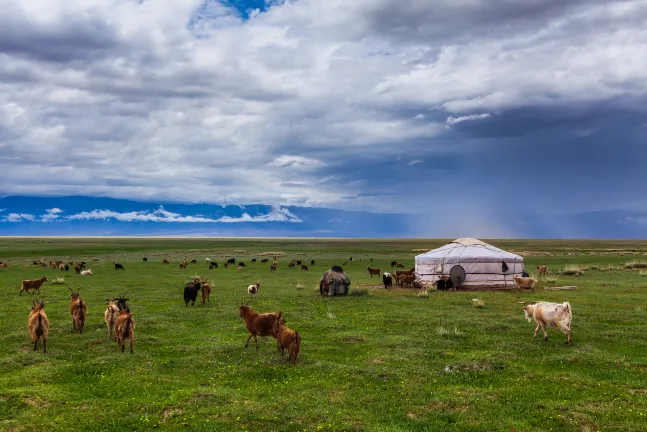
[0,0,647,236]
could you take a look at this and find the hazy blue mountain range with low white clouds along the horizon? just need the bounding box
[0,196,647,239]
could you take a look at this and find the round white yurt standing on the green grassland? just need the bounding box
[416,238,523,289]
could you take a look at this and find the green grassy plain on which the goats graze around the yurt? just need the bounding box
[0,239,647,431]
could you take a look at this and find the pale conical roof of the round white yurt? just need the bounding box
[416,238,523,264]
